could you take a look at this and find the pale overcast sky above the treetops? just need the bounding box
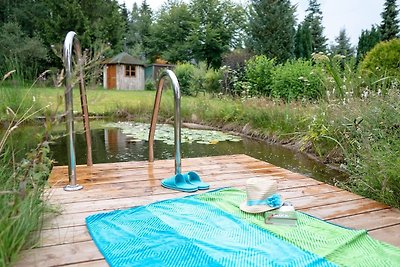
[118,0,392,46]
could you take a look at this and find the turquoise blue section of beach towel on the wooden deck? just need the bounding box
[86,194,335,267]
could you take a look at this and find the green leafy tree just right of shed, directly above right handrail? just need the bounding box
[150,1,195,63]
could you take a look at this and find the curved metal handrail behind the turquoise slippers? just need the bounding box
[149,70,181,174]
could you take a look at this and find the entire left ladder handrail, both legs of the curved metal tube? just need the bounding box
[63,31,93,191]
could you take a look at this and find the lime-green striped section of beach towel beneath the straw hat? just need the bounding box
[196,188,400,267]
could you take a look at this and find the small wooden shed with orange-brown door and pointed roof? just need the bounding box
[103,52,145,90]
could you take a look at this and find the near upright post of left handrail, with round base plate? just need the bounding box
[64,31,83,191]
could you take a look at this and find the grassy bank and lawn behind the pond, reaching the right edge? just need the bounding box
[1,88,400,207]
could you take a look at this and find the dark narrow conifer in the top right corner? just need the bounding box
[380,0,399,41]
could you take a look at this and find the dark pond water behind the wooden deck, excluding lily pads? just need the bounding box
[45,122,346,183]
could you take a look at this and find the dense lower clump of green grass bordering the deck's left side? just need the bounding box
[0,143,51,266]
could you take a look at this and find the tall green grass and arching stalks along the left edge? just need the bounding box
[0,72,51,266]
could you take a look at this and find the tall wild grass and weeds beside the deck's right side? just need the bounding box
[333,91,400,207]
